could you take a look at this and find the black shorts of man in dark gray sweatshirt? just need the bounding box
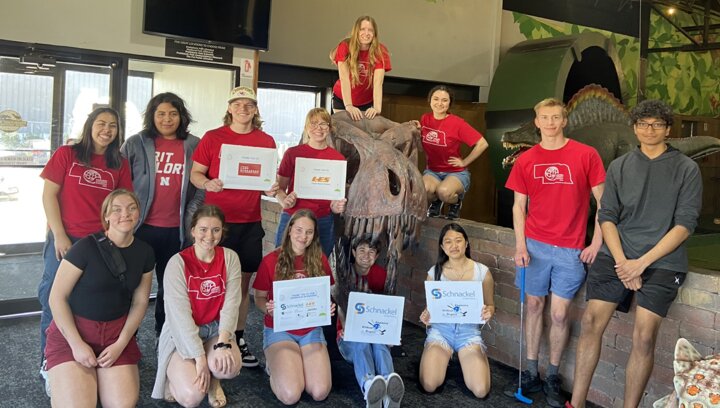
[585,253,686,317]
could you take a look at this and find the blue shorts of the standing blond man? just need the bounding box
[515,238,585,299]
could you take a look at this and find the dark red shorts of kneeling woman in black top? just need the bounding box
[45,315,141,370]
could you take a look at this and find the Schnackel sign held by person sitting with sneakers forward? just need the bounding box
[344,292,405,345]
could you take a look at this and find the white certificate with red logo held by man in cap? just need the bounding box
[219,144,278,191]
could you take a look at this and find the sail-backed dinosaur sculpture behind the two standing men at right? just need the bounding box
[501,84,720,168]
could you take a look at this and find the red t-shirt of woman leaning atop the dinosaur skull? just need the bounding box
[333,40,392,106]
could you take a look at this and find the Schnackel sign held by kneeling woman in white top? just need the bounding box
[425,281,485,323]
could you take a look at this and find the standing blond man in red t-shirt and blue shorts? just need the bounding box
[505,98,605,407]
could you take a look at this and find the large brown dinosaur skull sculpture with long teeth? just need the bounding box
[330,112,427,307]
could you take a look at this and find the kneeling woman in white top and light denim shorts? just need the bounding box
[420,222,495,398]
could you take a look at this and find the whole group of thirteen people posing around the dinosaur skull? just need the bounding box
[32,12,702,407]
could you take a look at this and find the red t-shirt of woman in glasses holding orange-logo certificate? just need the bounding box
[278,144,345,218]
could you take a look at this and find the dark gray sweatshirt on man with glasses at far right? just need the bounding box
[598,145,702,273]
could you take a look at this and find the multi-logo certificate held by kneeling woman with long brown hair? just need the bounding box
[273,276,330,332]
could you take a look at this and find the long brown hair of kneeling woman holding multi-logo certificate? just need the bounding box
[275,209,325,281]
